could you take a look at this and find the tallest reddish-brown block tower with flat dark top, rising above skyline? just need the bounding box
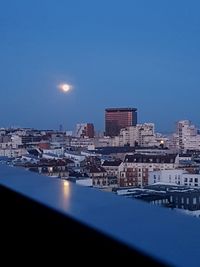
[105,108,137,136]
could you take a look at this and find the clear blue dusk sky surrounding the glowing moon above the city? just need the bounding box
[0,0,200,131]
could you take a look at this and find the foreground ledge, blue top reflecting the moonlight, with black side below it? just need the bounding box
[0,165,200,267]
